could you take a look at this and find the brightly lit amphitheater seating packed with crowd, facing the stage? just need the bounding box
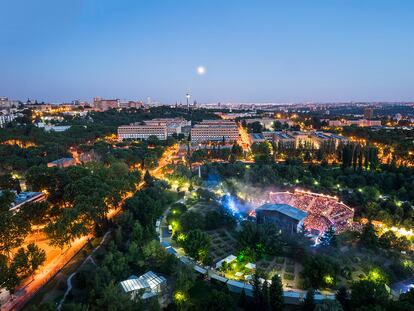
[269,190,354,235]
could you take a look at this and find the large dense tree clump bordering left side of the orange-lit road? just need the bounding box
[27,162,140,248]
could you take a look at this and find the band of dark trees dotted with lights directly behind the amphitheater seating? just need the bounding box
[202,161,414,228]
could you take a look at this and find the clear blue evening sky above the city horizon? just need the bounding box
[0,0,414,103]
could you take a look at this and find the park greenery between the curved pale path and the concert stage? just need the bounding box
[163,176,414,308]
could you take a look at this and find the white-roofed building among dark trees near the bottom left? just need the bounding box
[120,271,167,299]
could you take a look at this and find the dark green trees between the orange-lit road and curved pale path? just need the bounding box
[51,183,178,310]
